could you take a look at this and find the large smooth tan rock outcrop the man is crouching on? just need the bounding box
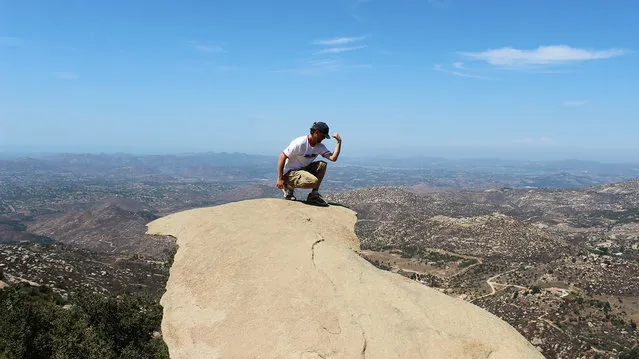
[148,199,542,359]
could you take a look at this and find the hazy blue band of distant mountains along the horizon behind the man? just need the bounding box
[0,153,639,190]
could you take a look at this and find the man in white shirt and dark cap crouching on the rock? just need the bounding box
[277,122,342,206]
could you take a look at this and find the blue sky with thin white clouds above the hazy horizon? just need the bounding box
[0,0,639,160]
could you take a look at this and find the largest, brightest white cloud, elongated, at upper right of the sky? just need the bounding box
[459,45,628,67]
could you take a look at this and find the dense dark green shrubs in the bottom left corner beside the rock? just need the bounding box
[0,284,168,359]
